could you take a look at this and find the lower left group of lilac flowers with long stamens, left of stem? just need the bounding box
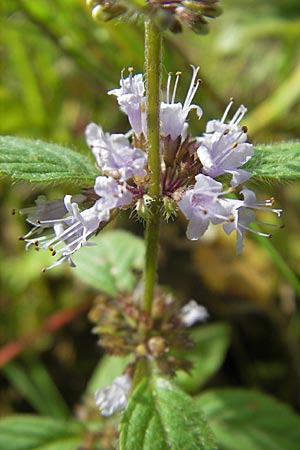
[20,118,147,270]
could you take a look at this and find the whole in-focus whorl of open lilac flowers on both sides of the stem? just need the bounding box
[21,66,281,268]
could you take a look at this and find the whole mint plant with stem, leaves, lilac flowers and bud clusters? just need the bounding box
[0,0,300,450]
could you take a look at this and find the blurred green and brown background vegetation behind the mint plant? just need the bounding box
[0,0,300,415]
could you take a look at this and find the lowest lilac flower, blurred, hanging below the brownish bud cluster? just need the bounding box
[95,374,131,416]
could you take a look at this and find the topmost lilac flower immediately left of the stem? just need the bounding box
[108,69,146,136]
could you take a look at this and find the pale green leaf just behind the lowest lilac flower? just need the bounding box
[86,355,132,394]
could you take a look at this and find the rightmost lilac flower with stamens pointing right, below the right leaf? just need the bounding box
[223,187,282,254]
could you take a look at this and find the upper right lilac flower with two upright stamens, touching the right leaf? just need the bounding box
[197,101,254,187]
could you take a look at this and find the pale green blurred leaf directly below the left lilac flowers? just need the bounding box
[73,230,144,296]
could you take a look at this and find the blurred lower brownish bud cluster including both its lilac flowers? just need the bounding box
[89,292,209,416]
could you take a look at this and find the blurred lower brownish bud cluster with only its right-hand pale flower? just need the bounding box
[89,287,208,374]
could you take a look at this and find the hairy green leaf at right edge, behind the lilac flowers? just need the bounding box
[243,141,300,180]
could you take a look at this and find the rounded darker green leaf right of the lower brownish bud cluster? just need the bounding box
[175,323,230,393]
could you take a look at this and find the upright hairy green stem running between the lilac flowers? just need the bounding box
[143,19,162,313]
